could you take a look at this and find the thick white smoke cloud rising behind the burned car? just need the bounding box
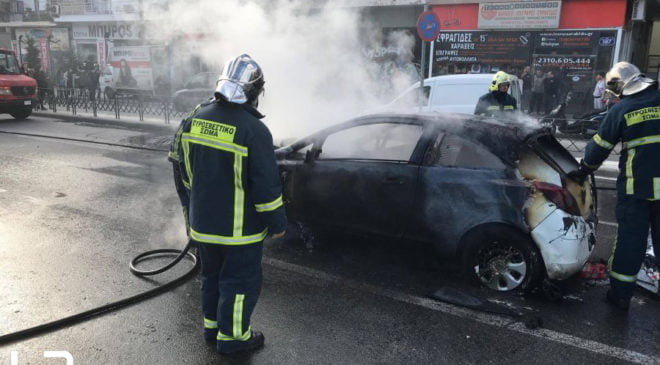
[147,0,417,138]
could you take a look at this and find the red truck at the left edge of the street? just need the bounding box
[0,48,37,120]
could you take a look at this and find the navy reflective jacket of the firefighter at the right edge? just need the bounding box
[584,86,660,200]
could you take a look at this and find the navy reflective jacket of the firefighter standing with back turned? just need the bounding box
[169,101,286,245]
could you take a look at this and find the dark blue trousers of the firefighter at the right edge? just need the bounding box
[609,194,660,300]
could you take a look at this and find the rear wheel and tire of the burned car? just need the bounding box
[463,225,545,291]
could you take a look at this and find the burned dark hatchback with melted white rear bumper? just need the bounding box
[276,113,596,291]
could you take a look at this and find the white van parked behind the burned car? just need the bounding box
[387,74,522,114]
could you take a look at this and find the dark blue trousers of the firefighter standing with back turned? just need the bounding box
[197,241,263,341]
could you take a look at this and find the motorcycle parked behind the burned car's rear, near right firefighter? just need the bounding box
[539,95,607,139]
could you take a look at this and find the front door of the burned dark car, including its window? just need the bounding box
[292,120,424,236]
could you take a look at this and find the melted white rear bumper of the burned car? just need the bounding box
[531,209,596,280]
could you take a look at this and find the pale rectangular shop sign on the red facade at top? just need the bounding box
[477,1,561,29]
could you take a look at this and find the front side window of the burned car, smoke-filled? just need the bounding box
[318,123,423,161]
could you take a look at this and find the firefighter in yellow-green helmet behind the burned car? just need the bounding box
[474,71,517,117]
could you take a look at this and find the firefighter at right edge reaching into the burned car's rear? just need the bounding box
[569,62,660,310]
